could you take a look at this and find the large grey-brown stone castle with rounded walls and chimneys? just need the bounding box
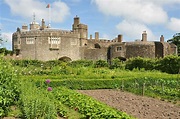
[12,16,177,61]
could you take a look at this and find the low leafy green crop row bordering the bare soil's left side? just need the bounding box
[55,87,133,119]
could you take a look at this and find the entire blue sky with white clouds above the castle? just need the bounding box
[0,0,180,49]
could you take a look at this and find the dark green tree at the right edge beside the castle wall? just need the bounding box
[167,33,180,55]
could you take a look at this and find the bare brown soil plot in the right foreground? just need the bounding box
[78,89,180,119]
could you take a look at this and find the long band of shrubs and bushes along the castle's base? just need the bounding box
[11,55,180,75]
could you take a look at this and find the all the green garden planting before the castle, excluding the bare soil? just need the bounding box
[0,56,180,119]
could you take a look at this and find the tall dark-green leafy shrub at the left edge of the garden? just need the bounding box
[0,56,19,117]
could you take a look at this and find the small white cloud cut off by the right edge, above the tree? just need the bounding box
[167,18,180,32]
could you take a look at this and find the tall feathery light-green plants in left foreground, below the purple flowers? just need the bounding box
[20,81,57,119]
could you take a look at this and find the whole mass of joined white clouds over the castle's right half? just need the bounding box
[91,0,180,40]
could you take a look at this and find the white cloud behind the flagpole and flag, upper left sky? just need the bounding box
[4,0,70,22]
